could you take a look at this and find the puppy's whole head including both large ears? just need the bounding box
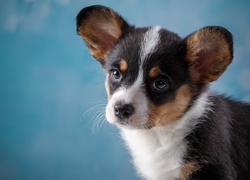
[77,6,233,129]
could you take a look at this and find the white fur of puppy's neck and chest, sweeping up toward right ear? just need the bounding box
[122,91,211,180]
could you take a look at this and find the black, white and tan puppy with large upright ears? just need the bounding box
[76,5,250,180]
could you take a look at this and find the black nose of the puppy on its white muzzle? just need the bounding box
[114,102,134,120]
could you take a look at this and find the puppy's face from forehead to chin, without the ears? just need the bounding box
[105,27,189,128]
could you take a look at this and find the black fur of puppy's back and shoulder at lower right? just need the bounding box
[186,95,250,180]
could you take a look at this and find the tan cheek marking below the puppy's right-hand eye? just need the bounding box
[147,85,191,127]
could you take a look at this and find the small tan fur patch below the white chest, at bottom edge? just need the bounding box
[179,161,198,180]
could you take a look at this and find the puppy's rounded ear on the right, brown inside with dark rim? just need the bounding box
[184,26,233,84]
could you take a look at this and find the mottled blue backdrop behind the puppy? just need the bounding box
[0,0,250,180]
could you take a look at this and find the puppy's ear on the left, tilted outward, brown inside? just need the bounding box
[76,5,129,65]
